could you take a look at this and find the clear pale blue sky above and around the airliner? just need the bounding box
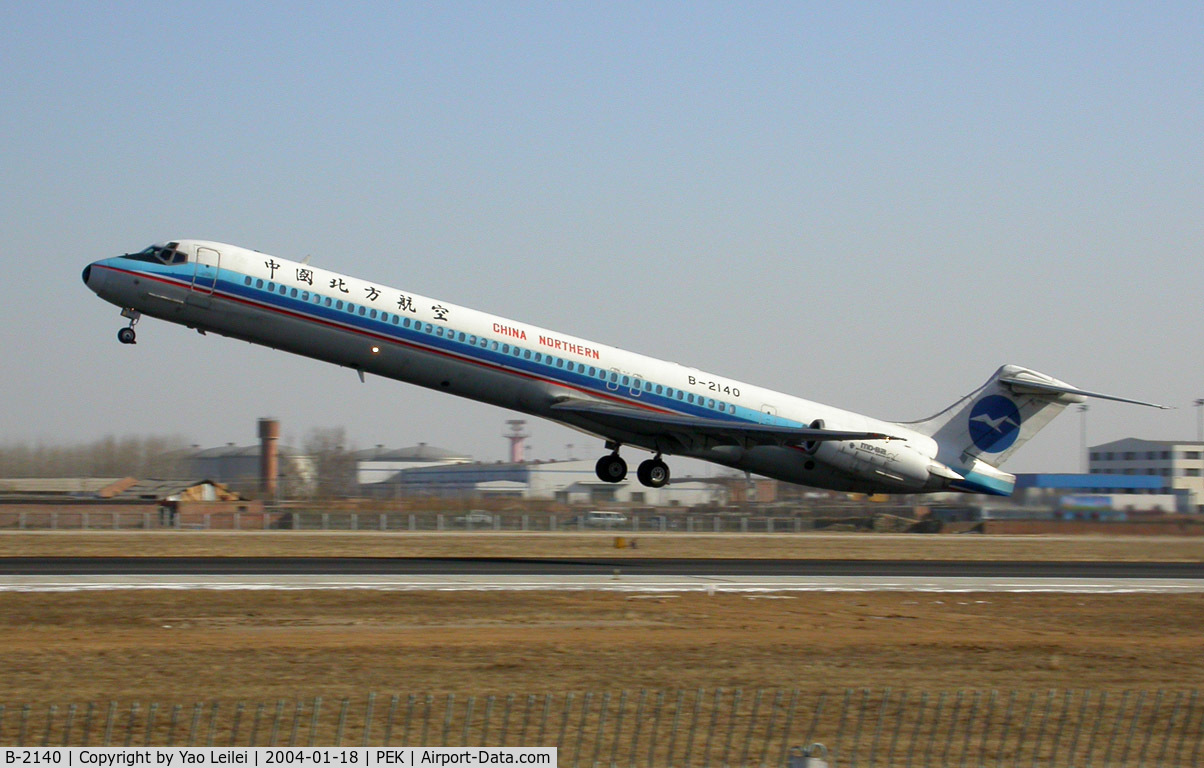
[0,2,1204,471]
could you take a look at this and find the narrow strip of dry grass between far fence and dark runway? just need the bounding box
[0,531,1204,562]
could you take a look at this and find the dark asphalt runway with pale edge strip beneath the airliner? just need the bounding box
[0,557,1204,596]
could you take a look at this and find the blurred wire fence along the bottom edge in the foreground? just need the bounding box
[0,689,1204,768]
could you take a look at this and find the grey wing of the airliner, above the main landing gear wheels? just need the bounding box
[551,398,902,447]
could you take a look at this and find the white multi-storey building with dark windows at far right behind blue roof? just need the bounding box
[1087,437,1204,512]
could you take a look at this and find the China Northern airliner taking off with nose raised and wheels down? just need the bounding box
[83,240,1165,496]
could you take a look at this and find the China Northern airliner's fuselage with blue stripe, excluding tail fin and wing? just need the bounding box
[84,241,949,492]
